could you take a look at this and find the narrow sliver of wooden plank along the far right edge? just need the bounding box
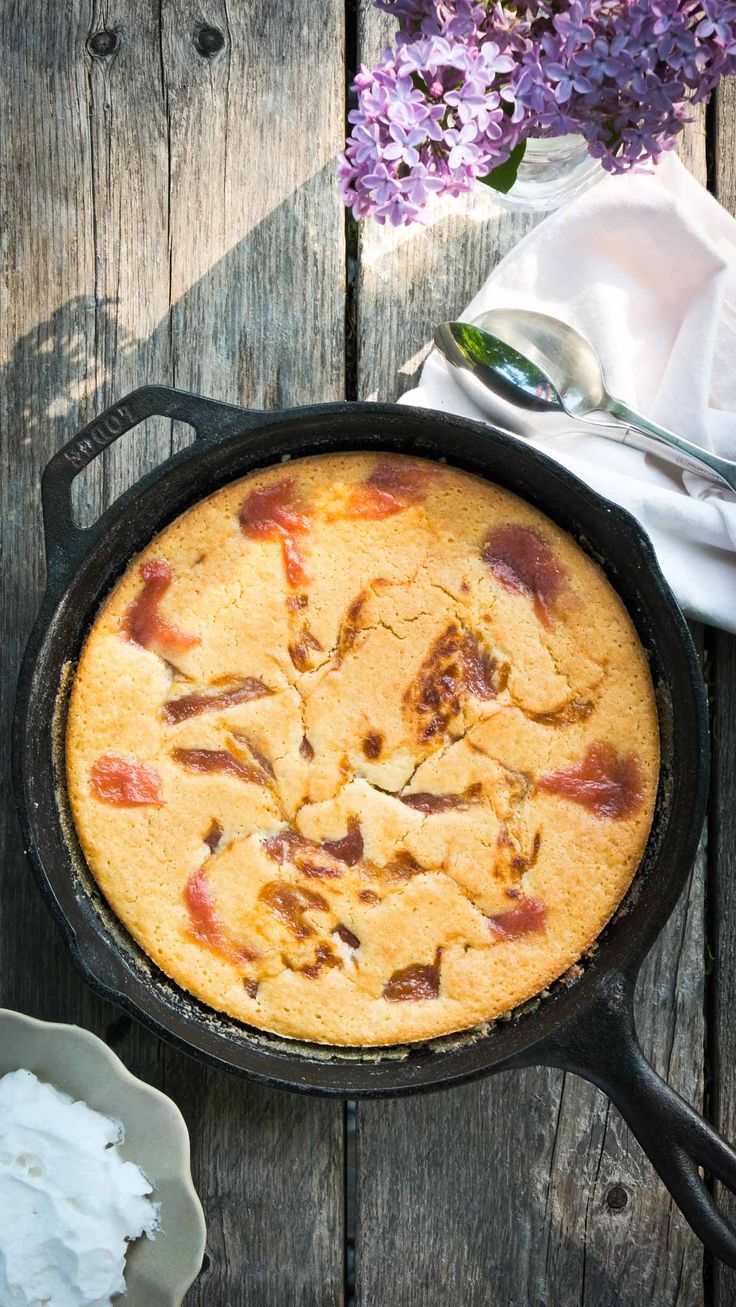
[709,71,736,1307]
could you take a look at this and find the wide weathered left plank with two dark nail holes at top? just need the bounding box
[0,0,344,1307]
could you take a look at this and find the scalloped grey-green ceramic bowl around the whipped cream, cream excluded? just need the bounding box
[0,1008,207,1307]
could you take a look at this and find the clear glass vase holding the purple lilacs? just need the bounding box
[495,136,605,213]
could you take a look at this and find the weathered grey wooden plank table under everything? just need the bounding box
[0,0,736,1307]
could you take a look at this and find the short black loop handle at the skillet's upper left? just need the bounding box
[41,386,264,588]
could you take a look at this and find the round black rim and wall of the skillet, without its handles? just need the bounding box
[13,392,707,1097]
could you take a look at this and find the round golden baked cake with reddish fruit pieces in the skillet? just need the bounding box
[67,454,659,1046]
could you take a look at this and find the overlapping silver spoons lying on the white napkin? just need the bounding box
[434,308,736,490]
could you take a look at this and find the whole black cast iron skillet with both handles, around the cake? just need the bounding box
[13,386,736,1266]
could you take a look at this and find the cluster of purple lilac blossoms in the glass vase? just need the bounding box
[339,0,736,225]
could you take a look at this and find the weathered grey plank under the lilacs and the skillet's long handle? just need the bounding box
[356,0,705,1307]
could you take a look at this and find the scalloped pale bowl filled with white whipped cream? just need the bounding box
[0,1009,205,1307]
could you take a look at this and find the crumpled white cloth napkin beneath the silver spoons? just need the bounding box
[403,154,736,631]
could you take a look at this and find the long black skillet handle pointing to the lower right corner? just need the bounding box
[535,974,736,1266]
